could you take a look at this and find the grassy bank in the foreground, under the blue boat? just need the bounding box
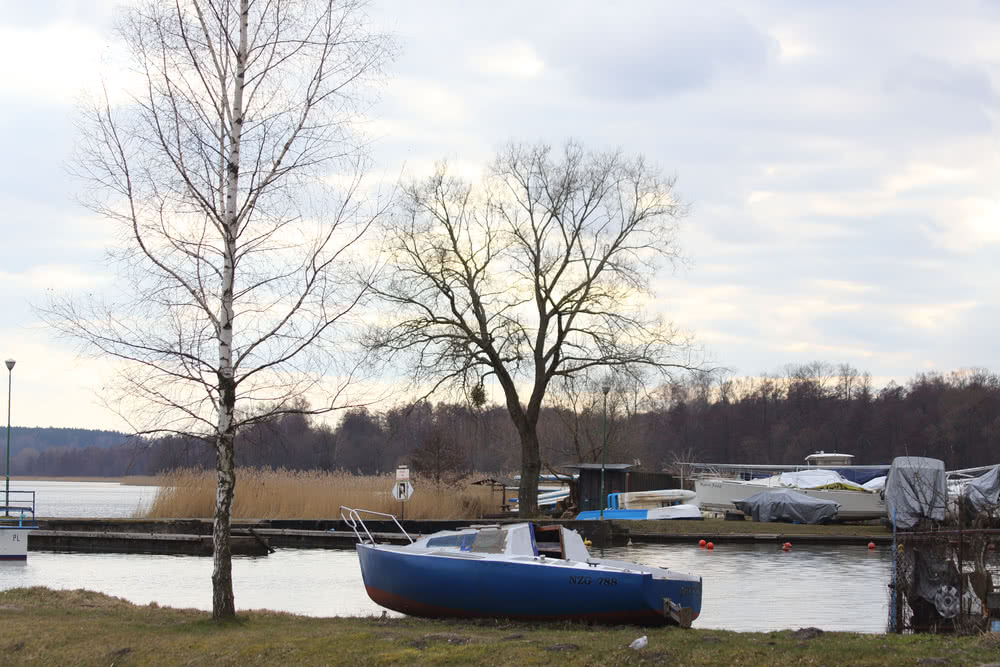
[0,588,1000,665]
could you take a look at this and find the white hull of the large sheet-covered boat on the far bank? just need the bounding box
[695,479,887,521]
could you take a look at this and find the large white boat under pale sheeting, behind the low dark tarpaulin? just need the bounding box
[694,468,887,521]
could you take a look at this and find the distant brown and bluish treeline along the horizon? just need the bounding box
[11,362,1000,478]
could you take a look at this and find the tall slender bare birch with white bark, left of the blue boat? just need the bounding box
[46,0,390,619]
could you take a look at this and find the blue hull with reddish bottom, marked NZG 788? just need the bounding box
[357,544,701,625]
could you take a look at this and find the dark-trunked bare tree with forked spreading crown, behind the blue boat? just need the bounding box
[368,143,692,516]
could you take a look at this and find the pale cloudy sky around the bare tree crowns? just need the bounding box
[0,0,1000,428]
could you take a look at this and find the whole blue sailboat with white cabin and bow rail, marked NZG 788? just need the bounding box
[341,507,702,627]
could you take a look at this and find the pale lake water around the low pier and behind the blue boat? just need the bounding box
[0,482,891,633]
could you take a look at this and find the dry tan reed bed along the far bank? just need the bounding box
[145,469,502,519]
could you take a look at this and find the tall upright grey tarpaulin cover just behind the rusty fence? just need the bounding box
[885,456,948,530]
